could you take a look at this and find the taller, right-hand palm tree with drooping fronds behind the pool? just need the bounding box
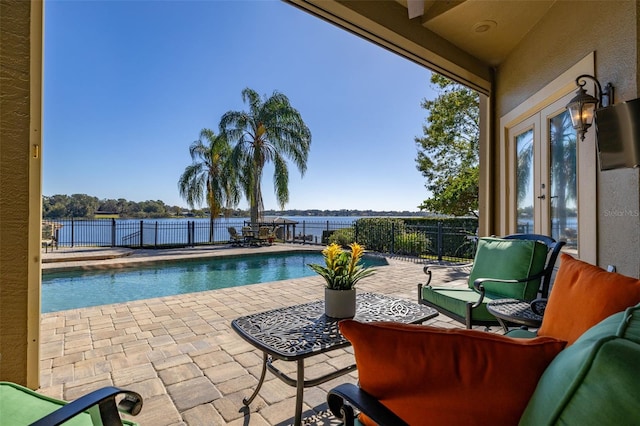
[220,88,311,226]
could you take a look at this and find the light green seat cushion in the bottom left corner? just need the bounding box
[0,382,136,426]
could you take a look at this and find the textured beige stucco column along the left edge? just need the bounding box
[0,0,42,388]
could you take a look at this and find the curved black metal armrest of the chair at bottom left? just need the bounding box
[31,386,142,426]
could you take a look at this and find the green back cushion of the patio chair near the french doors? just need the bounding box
[469,237,547,300]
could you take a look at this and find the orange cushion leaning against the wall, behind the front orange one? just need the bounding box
[538,253,640,345]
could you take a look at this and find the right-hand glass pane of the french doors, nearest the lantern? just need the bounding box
[549,111,578,248]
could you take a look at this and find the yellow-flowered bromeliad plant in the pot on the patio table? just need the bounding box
[309,243,374,290]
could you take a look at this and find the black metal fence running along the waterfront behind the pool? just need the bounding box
[47,219,476,261]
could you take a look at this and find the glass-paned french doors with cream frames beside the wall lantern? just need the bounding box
[508,94,579,251]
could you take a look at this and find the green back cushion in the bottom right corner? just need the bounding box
[520,305,640,425]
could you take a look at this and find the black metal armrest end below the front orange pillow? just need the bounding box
[327,383,408,426]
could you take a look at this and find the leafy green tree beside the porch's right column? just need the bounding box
[415,73,480,216]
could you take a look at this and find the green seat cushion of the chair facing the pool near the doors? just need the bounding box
[422,286,504,321]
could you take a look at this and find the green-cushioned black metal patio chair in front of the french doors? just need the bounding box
[418,234,565,329]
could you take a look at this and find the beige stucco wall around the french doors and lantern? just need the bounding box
[494,0,640,277]
